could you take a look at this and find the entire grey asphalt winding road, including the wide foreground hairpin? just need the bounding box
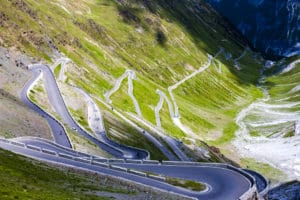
[9,54,268,200]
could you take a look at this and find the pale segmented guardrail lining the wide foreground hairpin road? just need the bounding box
[0,138,257,200]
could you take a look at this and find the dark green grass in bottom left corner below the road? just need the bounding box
[0,147,129,199]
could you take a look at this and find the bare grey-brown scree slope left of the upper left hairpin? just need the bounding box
[0,48,52,139]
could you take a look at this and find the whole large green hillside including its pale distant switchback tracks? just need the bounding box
[0,0,286,191]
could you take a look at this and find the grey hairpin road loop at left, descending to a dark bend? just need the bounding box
[21,64,149,159]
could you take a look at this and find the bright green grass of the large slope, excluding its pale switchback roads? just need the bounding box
[0,0,260,153]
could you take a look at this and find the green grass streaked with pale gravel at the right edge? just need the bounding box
[245,57,300,137]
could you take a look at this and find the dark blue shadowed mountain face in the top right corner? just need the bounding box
[206,0,300,56]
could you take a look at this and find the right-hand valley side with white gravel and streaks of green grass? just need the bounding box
[234,56,300,180]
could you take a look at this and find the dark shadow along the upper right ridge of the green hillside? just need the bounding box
[119,0,258,84]
